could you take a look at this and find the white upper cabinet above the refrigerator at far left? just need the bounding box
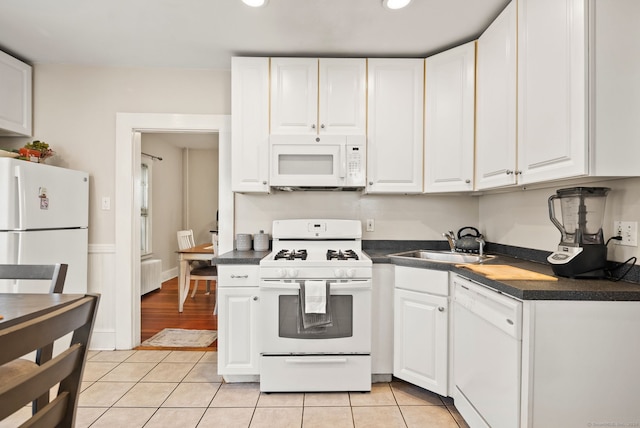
[0,52,32,136]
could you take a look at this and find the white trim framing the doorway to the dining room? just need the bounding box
[114,113,234,349]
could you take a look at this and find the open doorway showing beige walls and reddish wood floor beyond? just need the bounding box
[140,132,219,342]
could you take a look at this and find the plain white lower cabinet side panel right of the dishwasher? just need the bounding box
[520,300,640,428]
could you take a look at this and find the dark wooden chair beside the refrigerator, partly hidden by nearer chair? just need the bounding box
[0,263,69,414]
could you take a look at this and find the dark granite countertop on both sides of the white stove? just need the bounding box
[214,241,640,301]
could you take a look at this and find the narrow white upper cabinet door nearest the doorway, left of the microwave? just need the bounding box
[231,58,269,193]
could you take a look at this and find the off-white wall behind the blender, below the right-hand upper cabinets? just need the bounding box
[479,176,640,261]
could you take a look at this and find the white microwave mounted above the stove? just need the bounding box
[269,135,367,189]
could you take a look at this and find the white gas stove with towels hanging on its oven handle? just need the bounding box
[259,219,372,392]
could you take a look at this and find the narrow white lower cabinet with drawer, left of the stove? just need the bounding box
[217,265,260,380]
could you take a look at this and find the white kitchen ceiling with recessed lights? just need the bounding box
[0,0,509,69]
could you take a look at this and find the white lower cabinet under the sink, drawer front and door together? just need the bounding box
[393,266,449,396]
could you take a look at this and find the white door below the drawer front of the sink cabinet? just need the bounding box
[393,288,449,396]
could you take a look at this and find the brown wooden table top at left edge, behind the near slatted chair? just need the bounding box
[0,293,84,330]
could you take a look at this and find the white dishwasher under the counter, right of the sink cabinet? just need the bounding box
[452,275,522,428]
